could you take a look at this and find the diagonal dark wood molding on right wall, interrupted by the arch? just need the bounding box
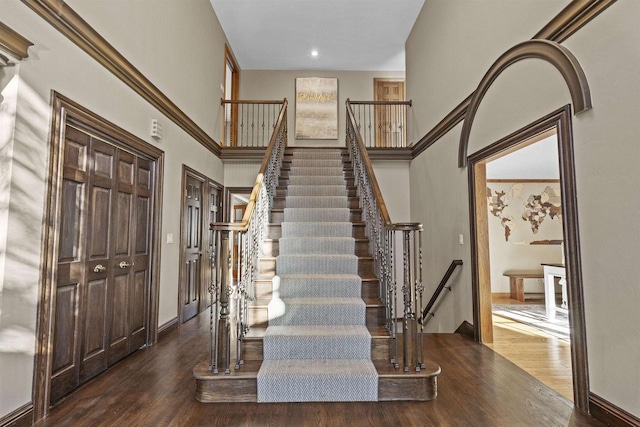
[412,0,616,158]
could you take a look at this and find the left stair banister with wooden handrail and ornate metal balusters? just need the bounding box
[209,99,287,374]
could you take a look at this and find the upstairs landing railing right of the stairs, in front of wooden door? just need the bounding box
[347,100,411,148]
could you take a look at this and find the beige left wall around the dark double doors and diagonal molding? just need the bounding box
[0,0,226,417]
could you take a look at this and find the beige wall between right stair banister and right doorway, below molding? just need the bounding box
[409,125,473,332]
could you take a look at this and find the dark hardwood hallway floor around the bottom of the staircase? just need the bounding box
[36,314,602,427]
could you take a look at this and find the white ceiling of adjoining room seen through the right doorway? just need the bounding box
[487,135,560,179]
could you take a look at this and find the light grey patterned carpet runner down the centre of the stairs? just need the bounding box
[257,149,378,402]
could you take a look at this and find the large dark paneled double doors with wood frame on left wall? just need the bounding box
[34,92,164,420]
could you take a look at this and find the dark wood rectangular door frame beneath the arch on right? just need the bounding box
[467,105,589,413]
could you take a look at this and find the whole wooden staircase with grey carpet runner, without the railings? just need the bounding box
[194,148,440,402]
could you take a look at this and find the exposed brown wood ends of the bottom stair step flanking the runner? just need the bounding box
[193,360,440,403]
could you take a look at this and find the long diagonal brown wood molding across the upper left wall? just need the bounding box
[22,0,221,157]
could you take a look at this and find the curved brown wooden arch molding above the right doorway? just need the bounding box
[458,39,591,168]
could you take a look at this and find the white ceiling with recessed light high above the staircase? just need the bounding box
[210,0,424,71]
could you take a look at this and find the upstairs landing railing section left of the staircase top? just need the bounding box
[220,99,286,148]
